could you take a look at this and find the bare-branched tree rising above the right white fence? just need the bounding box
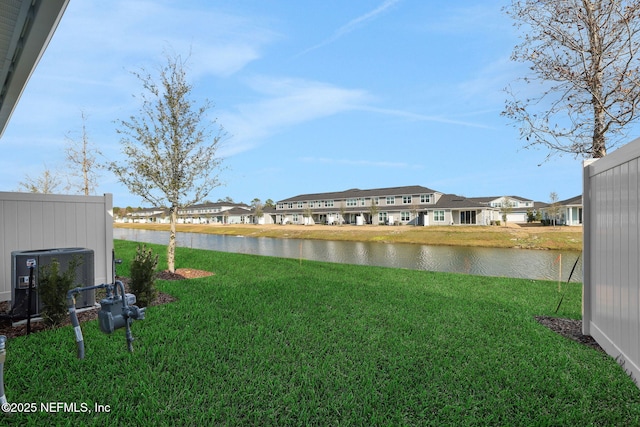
[502,0,640,158]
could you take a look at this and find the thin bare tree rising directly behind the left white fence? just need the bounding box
[65,111,101,196]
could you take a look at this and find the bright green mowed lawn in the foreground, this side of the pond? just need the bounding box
[0,241,640,426]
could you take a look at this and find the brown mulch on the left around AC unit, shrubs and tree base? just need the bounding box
[0,268,214,339]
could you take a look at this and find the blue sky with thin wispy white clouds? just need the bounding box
[0,0,608,206]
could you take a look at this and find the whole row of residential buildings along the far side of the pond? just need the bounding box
[117,185,582,226]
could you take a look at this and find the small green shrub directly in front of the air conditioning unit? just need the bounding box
[38,257,82,326]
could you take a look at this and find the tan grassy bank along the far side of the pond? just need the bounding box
[114,223,582,251]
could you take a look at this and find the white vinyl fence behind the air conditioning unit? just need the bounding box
[0,192,113,302]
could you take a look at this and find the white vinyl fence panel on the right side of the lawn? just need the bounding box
[582,139,640,384]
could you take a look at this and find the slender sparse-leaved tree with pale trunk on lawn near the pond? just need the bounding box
[109,54,224,272]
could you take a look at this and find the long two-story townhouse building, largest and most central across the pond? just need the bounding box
[276,185,497,225]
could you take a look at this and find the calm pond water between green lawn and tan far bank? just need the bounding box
[113,228,582,282]
